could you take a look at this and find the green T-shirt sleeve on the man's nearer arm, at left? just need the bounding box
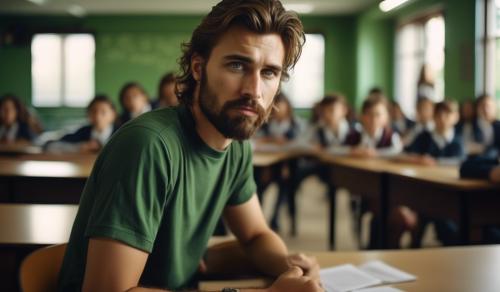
[85,126,169,252]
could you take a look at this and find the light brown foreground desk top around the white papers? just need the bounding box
[310,245,500,292]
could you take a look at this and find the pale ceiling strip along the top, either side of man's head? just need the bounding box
[0,0,380,16]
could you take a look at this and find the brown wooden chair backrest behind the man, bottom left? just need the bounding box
[19,244,66,292]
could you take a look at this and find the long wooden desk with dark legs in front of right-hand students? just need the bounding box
[317,153,500,249]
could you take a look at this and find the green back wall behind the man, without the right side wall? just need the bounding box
[0,15,356,128]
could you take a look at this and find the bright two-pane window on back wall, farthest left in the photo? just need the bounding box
[31,34,95,107]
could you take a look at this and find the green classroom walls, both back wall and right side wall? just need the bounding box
[0,0,475,128]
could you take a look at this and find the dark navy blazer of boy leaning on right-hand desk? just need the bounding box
[405,131,465,158]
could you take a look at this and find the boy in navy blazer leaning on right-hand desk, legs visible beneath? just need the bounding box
[389,101,465,248]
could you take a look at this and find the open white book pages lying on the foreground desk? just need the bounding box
[320,261,416,292]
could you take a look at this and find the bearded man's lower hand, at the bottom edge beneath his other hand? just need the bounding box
[268,267,324,292]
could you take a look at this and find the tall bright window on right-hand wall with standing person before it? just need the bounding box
[395,15,445,117]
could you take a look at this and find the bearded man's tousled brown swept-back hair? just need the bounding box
[176,0,305,104]
